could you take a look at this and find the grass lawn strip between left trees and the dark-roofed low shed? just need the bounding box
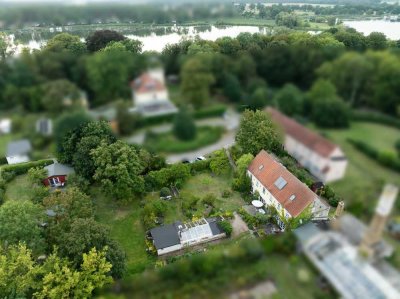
[92,188,156,278]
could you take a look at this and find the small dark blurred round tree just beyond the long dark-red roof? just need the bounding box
[273,83,304,116]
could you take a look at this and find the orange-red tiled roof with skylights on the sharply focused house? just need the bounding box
[248,150,317,217]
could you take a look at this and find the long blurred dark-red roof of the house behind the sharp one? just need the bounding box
[265,107,337,157]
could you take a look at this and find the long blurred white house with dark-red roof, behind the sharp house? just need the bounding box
[266,107,347,183]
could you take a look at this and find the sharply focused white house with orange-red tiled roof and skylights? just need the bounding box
[247,150,330,229]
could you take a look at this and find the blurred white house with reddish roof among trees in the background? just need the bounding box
[131,69,178,117]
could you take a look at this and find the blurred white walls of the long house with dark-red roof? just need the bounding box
[285,134,348,183]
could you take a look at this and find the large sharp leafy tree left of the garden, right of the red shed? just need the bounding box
[91,141,144,199]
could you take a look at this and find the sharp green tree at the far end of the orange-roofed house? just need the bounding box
[235,110,282,155]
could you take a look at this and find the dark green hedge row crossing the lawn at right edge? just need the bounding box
[347,139,400,172]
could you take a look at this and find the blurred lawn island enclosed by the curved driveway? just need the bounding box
[144,126,224,153]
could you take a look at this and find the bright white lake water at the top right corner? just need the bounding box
[343,20,400,40]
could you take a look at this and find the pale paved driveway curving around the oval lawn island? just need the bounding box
[126,109,240,163]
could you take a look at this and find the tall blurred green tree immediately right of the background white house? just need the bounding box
[181,55,215,108]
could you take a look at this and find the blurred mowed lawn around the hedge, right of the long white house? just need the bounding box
[319,122,400,212]
